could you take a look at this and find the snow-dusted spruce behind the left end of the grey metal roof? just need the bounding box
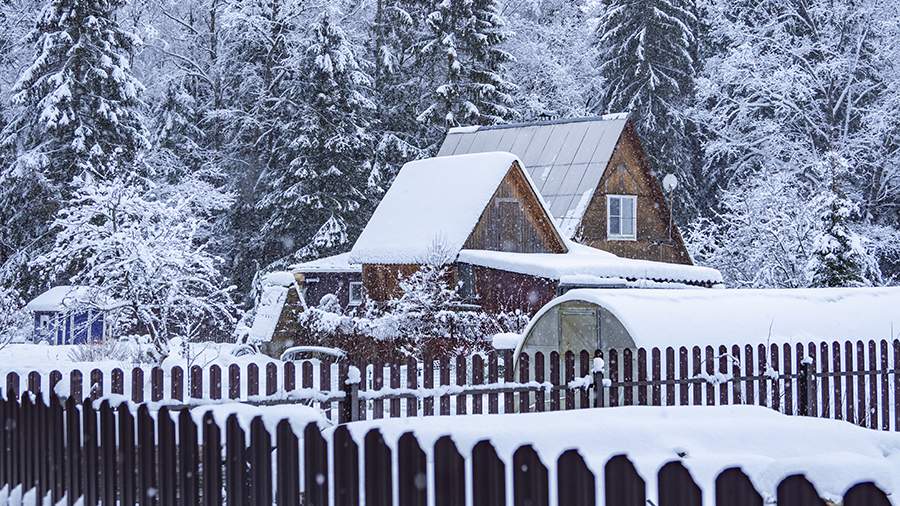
[419,0,516,143]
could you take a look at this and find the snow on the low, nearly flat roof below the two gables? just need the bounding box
[458,241,722,285]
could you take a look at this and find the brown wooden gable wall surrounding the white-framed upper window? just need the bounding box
[575,122,692,264]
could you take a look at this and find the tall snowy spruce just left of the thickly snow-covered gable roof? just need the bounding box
[261,13,374,264]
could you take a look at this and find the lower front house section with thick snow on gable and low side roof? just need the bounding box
[347,152,722,314]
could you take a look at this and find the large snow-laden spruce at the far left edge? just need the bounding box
[0,0,148,294]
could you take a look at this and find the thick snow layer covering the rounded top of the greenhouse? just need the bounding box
[526,288,900,347]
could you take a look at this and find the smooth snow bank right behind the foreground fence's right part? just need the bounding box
[329,406,900,505]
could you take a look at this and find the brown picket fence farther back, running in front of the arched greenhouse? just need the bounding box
[3,340,900,431]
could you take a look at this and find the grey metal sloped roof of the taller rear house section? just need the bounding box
[438,114,628,238]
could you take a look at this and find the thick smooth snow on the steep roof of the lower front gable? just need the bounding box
[349,152,564,264]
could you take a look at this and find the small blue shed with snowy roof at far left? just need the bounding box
[25,285,109,344]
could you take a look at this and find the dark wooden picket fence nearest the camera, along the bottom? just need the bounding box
[0,395,890,506]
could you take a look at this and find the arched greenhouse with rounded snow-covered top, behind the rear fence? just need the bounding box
[517,288,900,356]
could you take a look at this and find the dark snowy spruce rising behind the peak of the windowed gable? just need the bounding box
[597,0,696,180]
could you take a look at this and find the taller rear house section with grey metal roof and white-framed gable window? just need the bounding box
[438,114,691,264]
